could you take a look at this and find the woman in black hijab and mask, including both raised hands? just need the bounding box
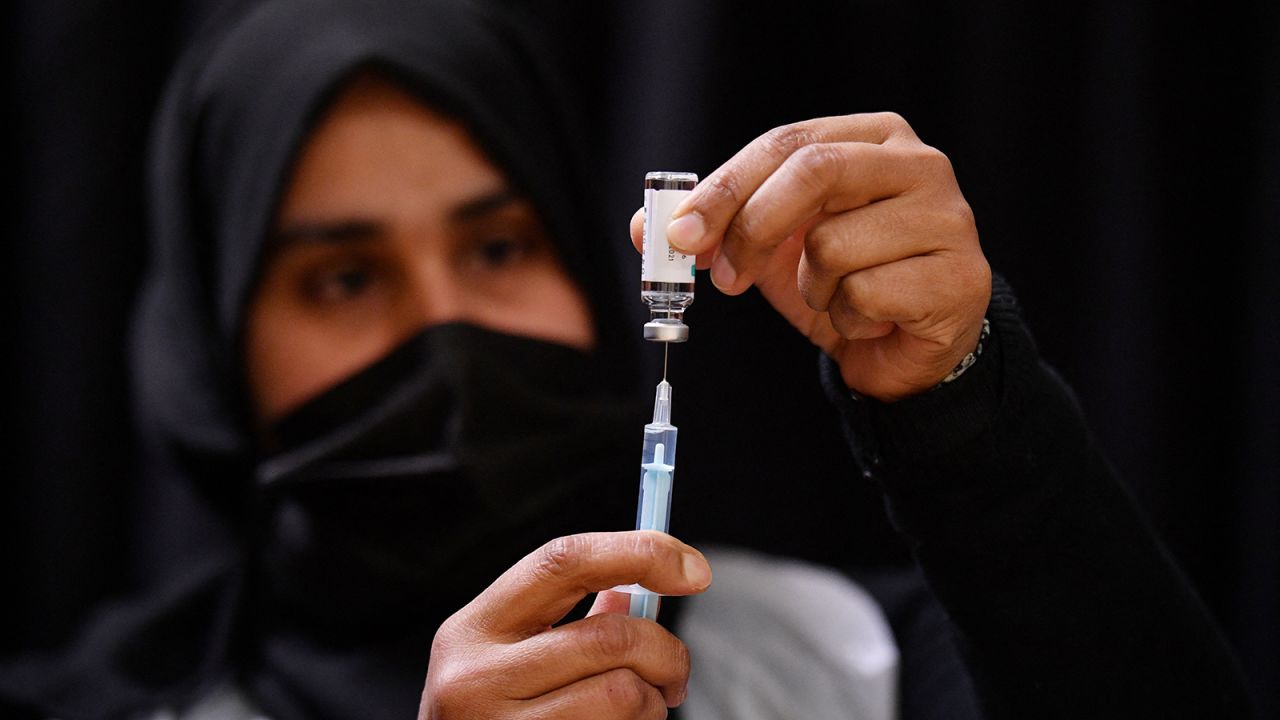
[0,0,1242,720]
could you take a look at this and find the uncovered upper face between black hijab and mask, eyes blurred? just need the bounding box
[246,78,595,423]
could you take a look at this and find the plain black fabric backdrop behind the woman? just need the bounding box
[10,0,1280,716]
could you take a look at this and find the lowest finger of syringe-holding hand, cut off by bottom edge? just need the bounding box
[520,669,667,720]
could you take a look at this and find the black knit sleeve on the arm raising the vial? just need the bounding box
[822,278,1248,720]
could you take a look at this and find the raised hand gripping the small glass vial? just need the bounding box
[631,113,991,401]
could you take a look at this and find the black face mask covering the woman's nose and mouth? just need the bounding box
[252,324,646,652]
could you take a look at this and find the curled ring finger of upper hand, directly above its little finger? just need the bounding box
[796,190,978,311]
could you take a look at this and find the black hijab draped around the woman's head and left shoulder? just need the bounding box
[3,0,640,717]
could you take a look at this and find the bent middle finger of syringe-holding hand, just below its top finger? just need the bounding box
[497,614,689,705]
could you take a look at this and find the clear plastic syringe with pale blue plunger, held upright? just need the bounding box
[630,378,676,620]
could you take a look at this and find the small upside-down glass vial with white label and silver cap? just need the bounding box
[640,172,698,342]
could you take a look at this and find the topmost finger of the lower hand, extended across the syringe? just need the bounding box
[461,530,712,637]
